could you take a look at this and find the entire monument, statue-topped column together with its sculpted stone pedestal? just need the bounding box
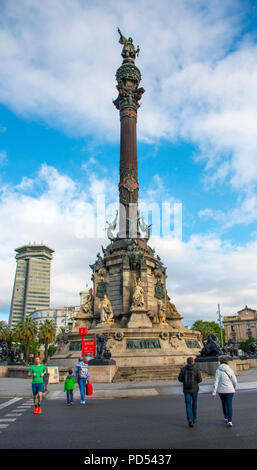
[51,29,202,380]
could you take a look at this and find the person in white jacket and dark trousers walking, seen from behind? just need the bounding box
[212,357,237,427]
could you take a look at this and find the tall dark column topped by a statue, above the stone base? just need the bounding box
[114,30,145,238]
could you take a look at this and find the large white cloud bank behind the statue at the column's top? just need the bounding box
[0,0,254,188]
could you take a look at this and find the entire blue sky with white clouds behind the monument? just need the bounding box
[0,0,257,324]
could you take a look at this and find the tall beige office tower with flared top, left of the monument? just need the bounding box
[9,244,54,326]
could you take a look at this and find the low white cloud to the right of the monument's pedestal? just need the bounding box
[151,235,257,320]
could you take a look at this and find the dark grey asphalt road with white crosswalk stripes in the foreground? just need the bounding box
[0,390,257,450]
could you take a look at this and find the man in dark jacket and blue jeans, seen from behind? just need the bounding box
[178,357,202,427]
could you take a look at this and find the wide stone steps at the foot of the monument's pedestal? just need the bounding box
[112,364,183,383]
